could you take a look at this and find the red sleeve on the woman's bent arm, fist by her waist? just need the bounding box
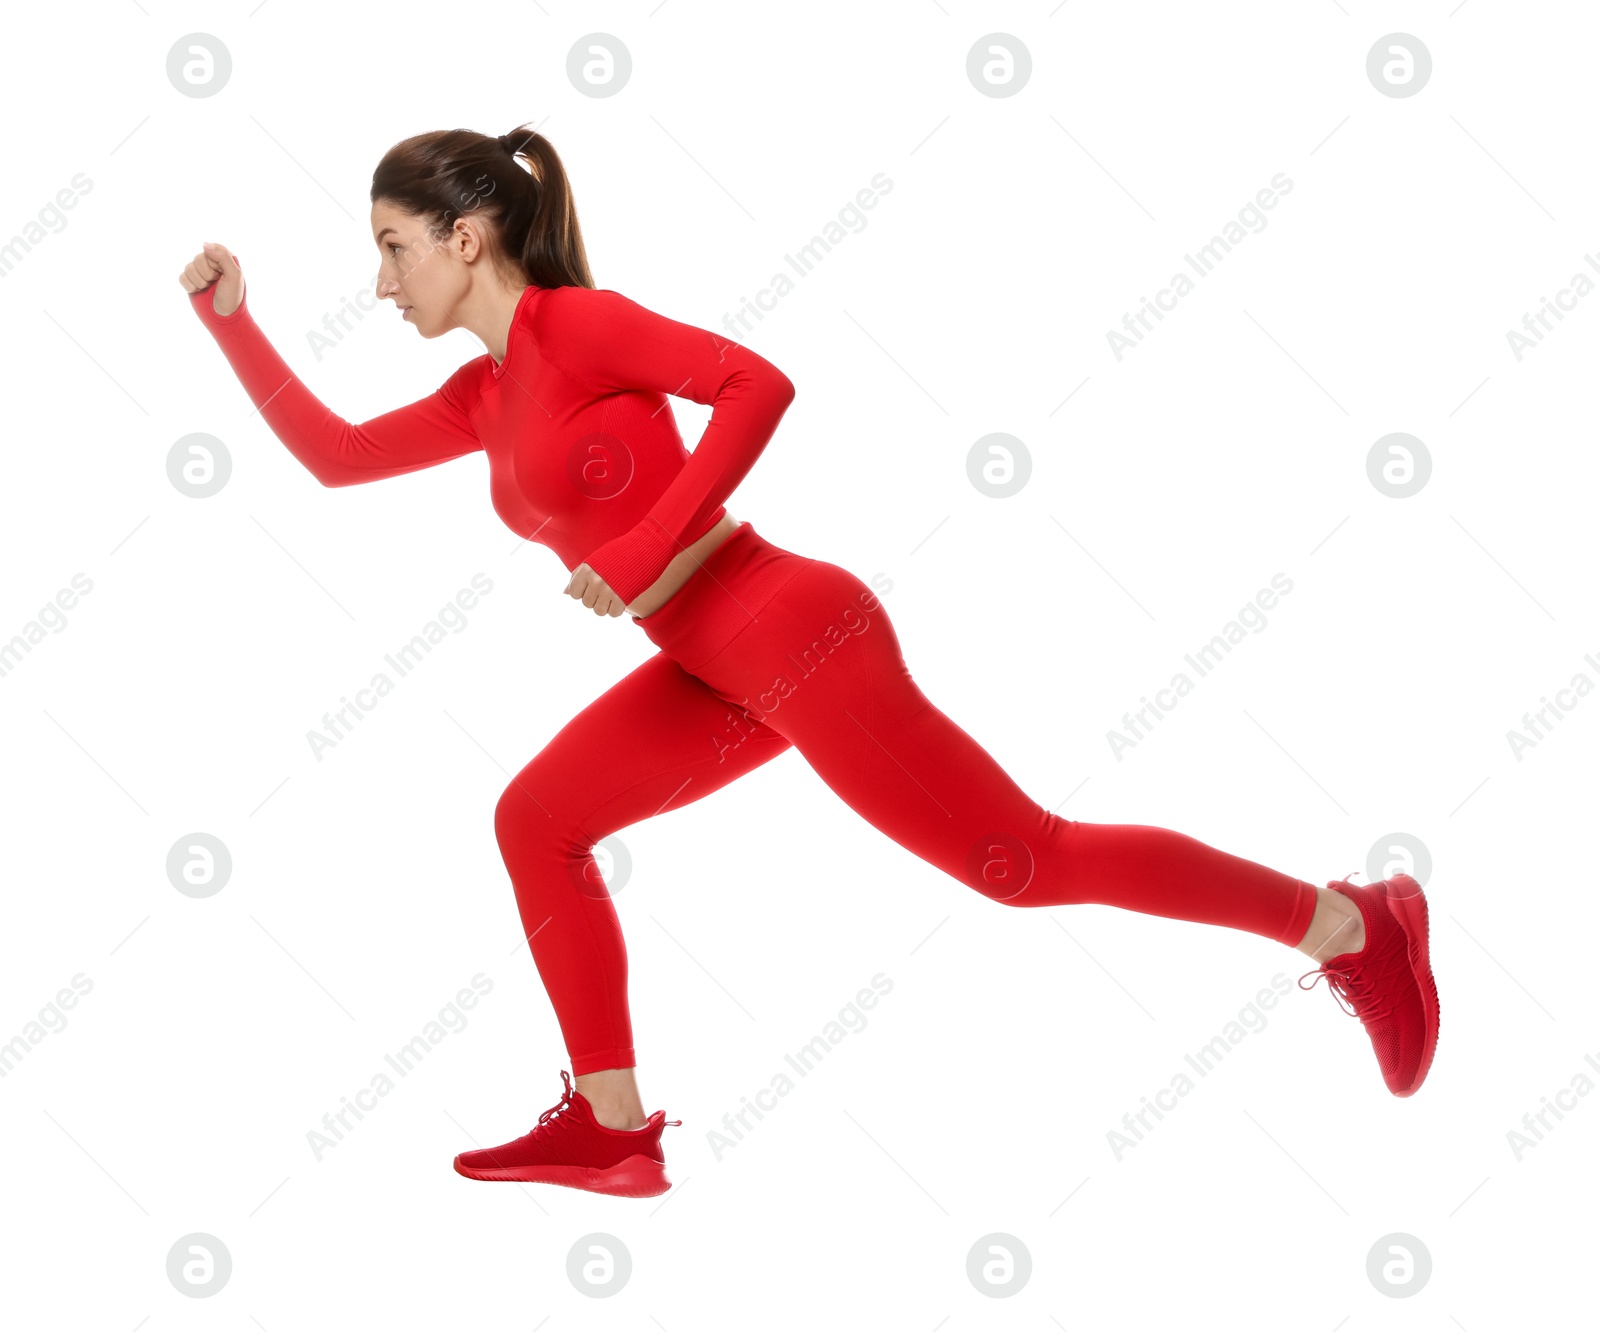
[533,287,795,602]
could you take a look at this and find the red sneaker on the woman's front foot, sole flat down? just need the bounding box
[456,1068,683,1198]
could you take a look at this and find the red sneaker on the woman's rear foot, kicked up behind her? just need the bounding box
[1299,874,1438,1097]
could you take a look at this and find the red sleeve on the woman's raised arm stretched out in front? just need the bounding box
[189,287,483,485]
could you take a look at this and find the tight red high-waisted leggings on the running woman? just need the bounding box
[494,522,1317,1074]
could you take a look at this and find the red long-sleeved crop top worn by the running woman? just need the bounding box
[189,270,795,605]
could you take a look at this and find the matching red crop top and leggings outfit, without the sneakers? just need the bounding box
[190,275,1317,1074]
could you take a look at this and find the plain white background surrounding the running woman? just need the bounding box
[0,0,1600,1332]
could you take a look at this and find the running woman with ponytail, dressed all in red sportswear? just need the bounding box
[179,130,1438,1198]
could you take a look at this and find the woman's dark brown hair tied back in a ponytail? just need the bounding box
[371,125,595,287]
